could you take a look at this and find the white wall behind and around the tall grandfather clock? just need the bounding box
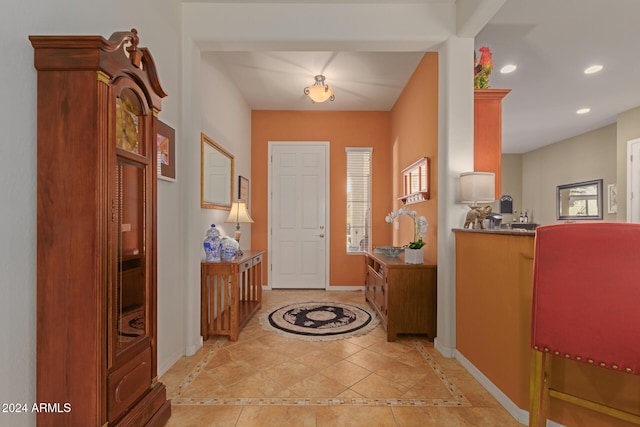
[0,0,182,427]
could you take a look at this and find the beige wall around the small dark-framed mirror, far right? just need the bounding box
[519,124,617,225]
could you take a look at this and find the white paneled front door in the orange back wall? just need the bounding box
[269,142,329,289]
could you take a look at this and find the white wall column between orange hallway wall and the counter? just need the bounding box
[435,37,474,357]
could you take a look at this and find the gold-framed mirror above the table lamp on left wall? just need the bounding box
[200,133,234,210]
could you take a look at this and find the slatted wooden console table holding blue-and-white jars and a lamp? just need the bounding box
[200,251,264,341]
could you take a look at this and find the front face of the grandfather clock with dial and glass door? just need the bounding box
[107,77,156,422]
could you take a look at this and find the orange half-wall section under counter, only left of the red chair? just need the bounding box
[455,230,535,409]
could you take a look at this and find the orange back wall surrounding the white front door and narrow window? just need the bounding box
[250,111,392,286]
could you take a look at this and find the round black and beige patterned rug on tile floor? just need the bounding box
[260,302,379,341]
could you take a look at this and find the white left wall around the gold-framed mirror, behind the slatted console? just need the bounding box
[181,18,251,355]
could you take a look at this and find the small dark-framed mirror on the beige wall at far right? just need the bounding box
[556,179,602,220]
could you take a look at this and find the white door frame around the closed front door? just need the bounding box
[267,141,331,290]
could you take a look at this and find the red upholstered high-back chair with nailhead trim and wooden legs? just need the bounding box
[529,223,640,427]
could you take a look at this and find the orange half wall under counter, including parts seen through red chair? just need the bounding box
[454,229,640,427]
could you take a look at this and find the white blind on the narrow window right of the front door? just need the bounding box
[346,147,373,253]
